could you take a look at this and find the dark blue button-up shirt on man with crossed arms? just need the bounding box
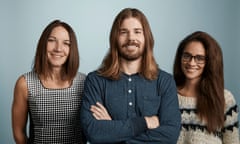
[81,70,181,144]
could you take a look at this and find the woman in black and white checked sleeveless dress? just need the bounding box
[12,20,85,144]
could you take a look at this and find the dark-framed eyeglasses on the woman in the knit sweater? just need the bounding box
[182,52,207,64]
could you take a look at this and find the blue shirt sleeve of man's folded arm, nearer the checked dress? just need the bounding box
[80,74,147,143]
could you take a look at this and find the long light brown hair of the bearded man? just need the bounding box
[98,8,158,80]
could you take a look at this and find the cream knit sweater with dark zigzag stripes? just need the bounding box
[177,90,239,144]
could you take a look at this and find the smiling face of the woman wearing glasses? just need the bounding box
[181,41,206,81]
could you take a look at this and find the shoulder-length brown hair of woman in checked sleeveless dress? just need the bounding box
[33,20,79,80]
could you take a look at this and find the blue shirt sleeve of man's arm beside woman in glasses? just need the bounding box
[127,72,181,144]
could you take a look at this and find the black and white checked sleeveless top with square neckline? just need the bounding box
[24,72,85,144]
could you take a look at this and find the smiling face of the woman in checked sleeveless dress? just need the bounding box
[47,26,70,67]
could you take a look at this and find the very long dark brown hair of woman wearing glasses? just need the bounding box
[173,31,225,132]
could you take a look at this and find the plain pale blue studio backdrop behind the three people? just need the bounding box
[0,0,240,144]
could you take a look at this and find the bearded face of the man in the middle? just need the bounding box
[118,17,145,61]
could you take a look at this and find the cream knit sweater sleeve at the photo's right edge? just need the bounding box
[223,90,239,144]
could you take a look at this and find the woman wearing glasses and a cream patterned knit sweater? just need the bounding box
[173,31,239,144]
